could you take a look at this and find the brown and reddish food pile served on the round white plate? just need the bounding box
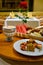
[20,39,42,52]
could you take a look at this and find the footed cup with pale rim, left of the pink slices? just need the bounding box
[3,26,16,41]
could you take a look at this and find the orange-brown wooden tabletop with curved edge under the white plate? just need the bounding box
[0,33,43,62]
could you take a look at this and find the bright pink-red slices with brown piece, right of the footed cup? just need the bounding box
[16,24,32,33]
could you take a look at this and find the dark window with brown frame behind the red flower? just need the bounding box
[0,0,33,11]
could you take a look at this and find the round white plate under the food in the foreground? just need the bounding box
[13,39,43,56]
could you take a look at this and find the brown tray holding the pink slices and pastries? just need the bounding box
[15,26,43,41]
